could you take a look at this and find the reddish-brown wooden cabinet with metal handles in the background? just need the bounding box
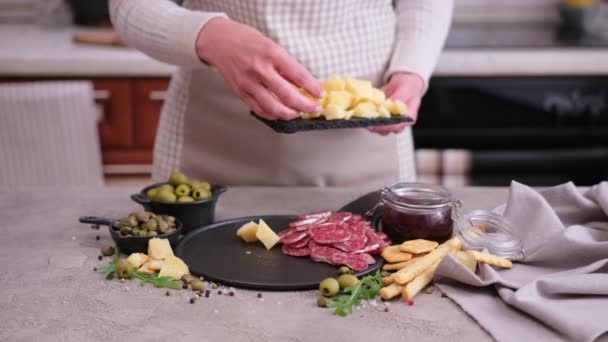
[0,77,169,174]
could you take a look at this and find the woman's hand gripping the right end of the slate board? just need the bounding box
[369,73,424,135]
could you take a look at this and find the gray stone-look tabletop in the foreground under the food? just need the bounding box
[0,188,508,342]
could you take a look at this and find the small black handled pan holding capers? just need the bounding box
[78,216,183,254]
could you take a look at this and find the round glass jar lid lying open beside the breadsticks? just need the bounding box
[455,210,525,261]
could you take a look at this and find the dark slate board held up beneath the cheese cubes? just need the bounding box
[251,112,414,134]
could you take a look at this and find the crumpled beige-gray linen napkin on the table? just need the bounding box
[435,182,608,341]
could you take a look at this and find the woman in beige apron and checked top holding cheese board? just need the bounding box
[110,0,453,187]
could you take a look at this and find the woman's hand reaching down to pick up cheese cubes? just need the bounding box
[196,18,323,120]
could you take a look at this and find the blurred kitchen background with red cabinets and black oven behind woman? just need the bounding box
[0,0,608,186]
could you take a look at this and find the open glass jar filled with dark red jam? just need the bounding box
[375,183,462,243]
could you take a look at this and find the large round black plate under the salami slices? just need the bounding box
[175,216,383,291]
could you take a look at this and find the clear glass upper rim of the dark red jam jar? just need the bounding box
[382,183,453,209]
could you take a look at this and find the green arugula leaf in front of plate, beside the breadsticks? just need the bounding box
[327,271,383,317]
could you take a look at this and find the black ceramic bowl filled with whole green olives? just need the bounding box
[131,183,227,234]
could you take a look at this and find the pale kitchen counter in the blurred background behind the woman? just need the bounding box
[0,24,608,77]
